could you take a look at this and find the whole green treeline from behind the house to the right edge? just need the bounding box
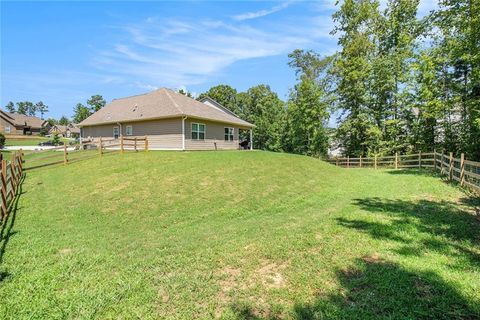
[193,0,480,159]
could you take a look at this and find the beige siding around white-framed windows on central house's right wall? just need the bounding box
[185,119,244,150]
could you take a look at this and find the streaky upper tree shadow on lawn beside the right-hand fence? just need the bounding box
[337,198,480,267]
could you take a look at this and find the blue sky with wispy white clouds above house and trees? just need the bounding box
[0,0,436,118]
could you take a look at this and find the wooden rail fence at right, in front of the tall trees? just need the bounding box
[327,152,480,194]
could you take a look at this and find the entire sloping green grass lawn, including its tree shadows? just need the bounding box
[0,152,480,319]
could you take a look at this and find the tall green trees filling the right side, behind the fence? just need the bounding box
[328,0,480,159]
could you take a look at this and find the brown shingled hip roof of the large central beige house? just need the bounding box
[78,88,254,127]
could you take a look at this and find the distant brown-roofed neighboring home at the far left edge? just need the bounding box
[0,110,50,135]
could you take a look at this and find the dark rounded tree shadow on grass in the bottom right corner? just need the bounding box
[294,257,480,319]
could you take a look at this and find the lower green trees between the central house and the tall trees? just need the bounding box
[191,73,328,155]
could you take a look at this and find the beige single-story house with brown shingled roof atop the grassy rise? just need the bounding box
[78,88,254,150]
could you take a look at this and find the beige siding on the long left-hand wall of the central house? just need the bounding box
[82,118,182,149]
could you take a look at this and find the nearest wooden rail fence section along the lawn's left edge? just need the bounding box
[0,151,23,225]
